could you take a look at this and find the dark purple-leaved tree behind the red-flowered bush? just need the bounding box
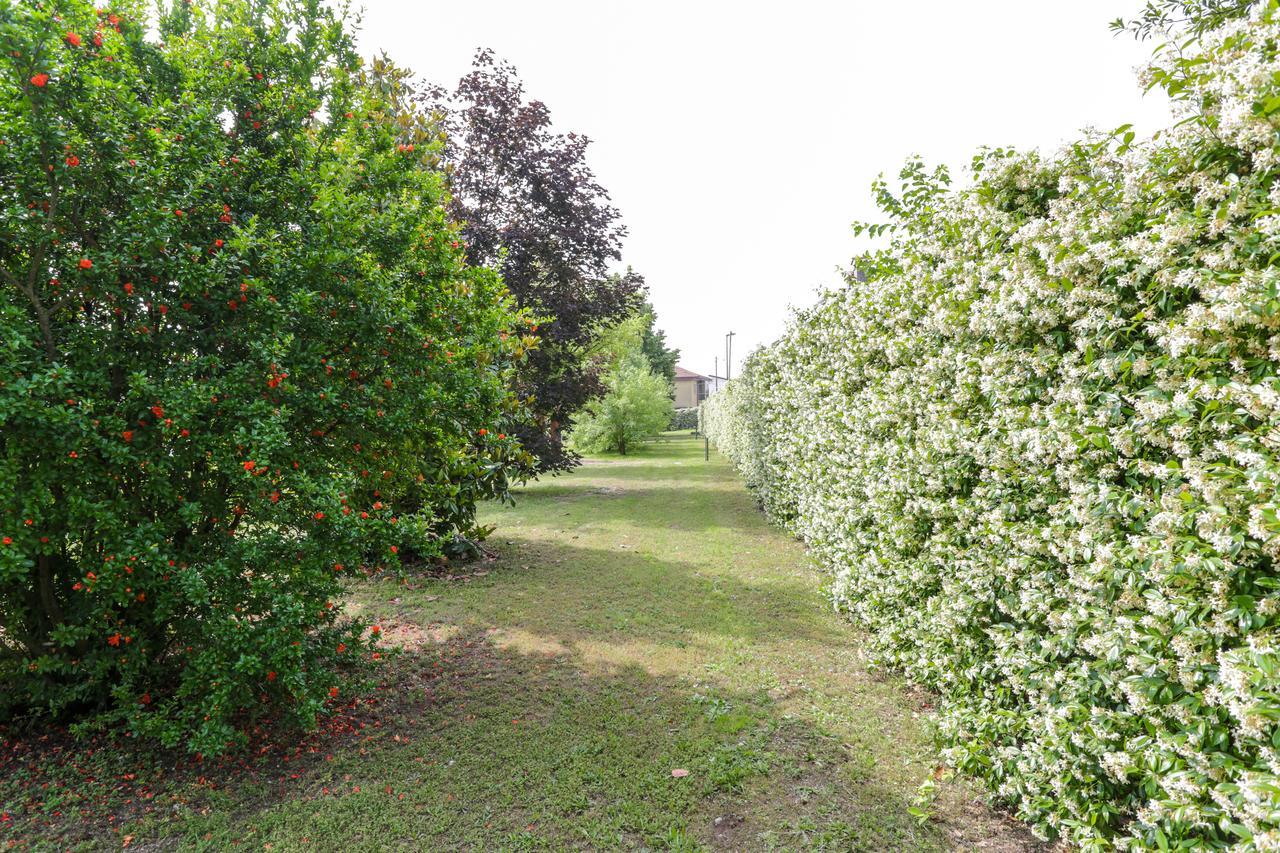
[422,50,644,473]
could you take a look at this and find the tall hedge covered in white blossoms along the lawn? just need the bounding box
[704,3,1280,849]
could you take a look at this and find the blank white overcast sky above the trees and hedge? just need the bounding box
[361,0,1167,374]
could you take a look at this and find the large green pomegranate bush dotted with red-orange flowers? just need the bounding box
[0,0,532,752]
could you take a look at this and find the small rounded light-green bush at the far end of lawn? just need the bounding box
[573,350,673,455]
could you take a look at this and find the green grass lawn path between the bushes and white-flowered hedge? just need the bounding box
[0,437,1033,850]
